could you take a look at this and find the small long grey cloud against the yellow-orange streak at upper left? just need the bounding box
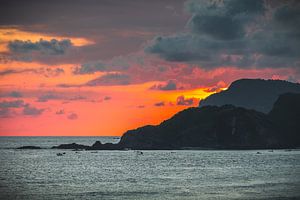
[8,39,72,55]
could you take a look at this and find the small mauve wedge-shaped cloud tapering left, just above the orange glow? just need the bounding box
[86,73,130,86]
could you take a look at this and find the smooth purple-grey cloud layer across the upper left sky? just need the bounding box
[0,0,187,63]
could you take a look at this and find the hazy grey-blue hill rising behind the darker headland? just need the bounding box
[199,79,300,113]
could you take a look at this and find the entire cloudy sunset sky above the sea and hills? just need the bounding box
[0,0,300,136]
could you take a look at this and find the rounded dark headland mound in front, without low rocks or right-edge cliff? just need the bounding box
[119,105,277,149]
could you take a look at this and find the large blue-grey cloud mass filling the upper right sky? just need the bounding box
[145,0,300,69]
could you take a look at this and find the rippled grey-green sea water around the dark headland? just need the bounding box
[0,137,300,200]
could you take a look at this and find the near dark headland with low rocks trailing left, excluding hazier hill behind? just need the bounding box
[49,89,300,150]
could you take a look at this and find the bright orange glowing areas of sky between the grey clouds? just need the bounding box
[0,29,216,136]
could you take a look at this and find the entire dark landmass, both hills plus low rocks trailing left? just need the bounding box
[20,79,300,150]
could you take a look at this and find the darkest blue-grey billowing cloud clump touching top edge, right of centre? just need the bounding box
[187,0,265,40]
